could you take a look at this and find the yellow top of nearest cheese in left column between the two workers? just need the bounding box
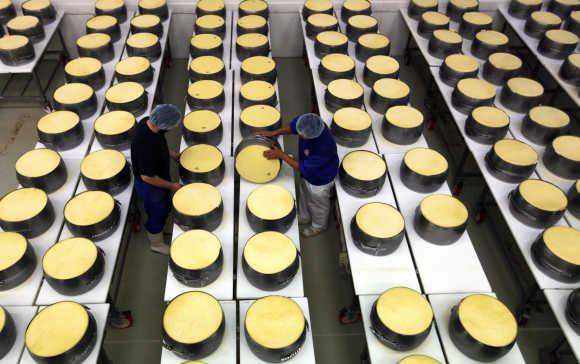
[163,291,224,344]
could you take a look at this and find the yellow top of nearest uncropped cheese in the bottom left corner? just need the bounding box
[25,301,89,357]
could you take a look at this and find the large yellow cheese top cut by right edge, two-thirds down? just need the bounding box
[542,226,580,265]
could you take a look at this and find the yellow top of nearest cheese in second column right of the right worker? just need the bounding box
[458,294,518,347]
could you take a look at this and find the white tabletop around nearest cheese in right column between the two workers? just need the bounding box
[239,293,316,364]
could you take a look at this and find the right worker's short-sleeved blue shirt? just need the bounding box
[290,117,338,186]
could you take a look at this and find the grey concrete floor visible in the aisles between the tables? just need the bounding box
[0,55,563,364]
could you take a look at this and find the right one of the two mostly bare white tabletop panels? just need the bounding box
[387,154,491,294]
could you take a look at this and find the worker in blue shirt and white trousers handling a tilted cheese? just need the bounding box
[257,114,338,237]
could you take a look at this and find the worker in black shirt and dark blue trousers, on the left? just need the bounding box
[131,104,182,254]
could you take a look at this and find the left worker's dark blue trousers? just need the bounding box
[135,178,171,234]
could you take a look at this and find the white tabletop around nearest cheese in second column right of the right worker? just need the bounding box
[428,292,525,364]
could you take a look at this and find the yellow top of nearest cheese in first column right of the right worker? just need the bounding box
[376,287,433,336]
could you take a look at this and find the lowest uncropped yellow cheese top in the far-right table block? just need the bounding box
[518,179,568,211]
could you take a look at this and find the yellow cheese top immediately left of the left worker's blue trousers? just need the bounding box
[64,191,115,226]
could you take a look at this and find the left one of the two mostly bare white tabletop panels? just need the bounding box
[336,149,421,295]
